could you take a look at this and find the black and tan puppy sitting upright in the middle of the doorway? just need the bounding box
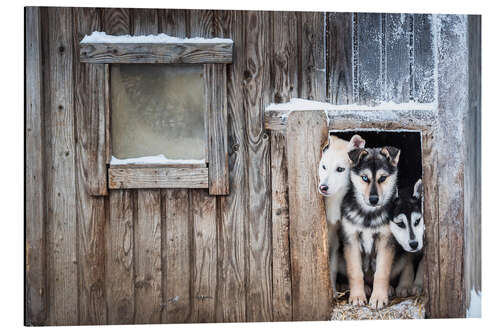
[340,147,400,309]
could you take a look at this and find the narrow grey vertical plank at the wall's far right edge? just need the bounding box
[464,15,481,314]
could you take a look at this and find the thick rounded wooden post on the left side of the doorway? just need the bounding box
[286,111,332,320]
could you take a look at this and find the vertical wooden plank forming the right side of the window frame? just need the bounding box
[205,65,229,195]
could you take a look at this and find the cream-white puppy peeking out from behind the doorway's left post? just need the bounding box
[318,135,365,295]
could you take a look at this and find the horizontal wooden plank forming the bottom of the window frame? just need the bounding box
[108,167,208,189]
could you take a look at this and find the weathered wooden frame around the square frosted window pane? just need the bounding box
[80,42,233,195]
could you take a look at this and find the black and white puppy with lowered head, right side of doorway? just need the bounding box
[390,179,425,297]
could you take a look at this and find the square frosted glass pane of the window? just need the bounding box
[111,64,205,160]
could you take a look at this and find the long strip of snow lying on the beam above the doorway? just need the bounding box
[266,98,436,111]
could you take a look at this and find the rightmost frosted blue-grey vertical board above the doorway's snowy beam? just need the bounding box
[413,14,437,103]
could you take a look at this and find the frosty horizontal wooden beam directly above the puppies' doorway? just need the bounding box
[264,109,437,131]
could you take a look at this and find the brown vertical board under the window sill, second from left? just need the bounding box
[134,190,163,324]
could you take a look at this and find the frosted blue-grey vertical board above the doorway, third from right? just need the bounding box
[354,13,385,105]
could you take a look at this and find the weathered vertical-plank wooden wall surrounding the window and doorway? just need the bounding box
[26,8,477,325]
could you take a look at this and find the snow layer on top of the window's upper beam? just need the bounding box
[80,31,233,44]
